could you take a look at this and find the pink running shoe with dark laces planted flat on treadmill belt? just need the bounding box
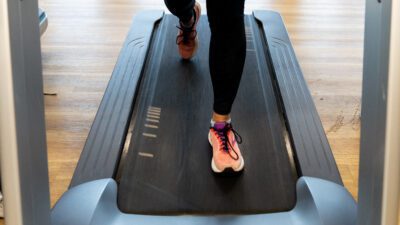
[208,123,244,174]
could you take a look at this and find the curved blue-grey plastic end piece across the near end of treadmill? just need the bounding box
[51,177,357,225]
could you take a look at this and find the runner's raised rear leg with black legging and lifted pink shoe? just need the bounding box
[164,0,201,59]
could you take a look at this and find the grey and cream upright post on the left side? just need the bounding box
[0,0,50,225]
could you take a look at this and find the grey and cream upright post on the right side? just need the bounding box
[358,0,400,225]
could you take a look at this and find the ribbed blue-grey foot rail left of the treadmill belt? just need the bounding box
[70,10,164,188]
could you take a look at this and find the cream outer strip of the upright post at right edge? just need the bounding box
[381,0,400,225]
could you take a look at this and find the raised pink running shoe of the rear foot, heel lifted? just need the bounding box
[176,2,201,60]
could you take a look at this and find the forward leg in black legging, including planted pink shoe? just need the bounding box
[207,0,246,173]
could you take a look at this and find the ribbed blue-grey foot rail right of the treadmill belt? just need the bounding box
[253,11,343,185]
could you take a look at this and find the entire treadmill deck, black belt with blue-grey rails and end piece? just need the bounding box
[51,11,357,225]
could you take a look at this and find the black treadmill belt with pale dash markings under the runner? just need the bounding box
[118,15,296,214]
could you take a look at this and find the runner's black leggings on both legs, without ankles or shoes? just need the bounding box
[165,0,246,115]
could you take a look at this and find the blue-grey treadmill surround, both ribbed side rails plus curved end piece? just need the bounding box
[51,11,357,225]
